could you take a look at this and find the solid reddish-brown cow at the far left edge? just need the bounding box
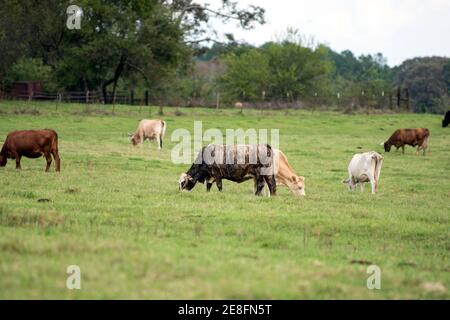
[0,129,61,172]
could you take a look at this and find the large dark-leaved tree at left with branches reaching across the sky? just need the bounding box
[0,0,264,102]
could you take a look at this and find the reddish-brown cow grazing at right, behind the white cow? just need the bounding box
[384,128,430,155]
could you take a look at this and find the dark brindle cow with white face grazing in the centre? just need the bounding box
[179,144,277,196]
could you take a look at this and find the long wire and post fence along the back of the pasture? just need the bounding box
[0,90,410,112]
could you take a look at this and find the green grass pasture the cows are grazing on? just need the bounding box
[0,102,450,299]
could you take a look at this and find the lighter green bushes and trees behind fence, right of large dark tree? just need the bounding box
[164,36,450,113]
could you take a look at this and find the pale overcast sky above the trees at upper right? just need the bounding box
[203,0,450,66]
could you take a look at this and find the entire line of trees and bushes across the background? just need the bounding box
[0,0,450,113]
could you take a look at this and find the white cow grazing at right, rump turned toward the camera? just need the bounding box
[343,151,383,194]
